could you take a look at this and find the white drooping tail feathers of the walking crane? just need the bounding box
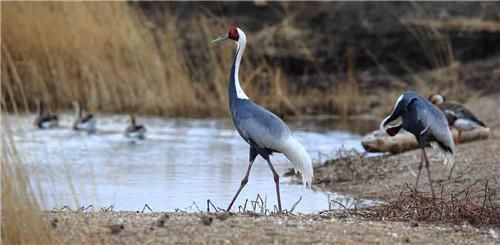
[281,136,313,187]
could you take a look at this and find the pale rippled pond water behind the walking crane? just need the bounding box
[3,115,378,213]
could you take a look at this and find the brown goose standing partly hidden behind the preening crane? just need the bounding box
[429,94,486,144]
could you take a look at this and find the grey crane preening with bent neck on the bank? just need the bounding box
[380,92,455,197]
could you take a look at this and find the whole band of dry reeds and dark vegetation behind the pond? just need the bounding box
[1,2,498,117]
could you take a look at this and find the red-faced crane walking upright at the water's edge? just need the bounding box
[212,27,313,213]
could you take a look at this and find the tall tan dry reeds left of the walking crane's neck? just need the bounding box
[2,2,244,116]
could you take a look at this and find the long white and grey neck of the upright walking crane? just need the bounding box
[228,32,248,107]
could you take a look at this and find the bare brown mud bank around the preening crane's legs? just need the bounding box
[308,130,500,205]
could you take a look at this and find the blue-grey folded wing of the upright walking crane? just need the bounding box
[233,100,290,152]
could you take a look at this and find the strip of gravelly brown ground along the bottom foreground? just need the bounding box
[47,212,500,244]
